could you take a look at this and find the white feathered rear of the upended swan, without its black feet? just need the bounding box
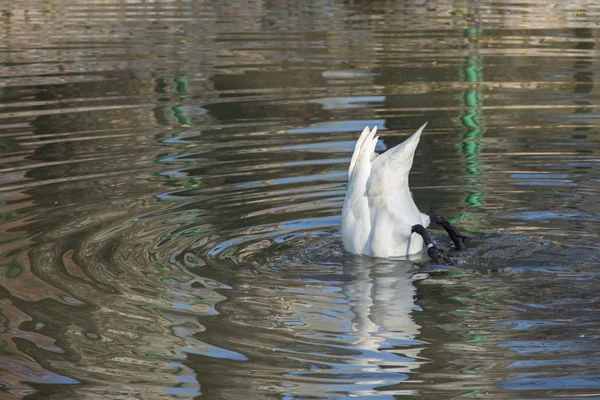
[342,123,430,257]
